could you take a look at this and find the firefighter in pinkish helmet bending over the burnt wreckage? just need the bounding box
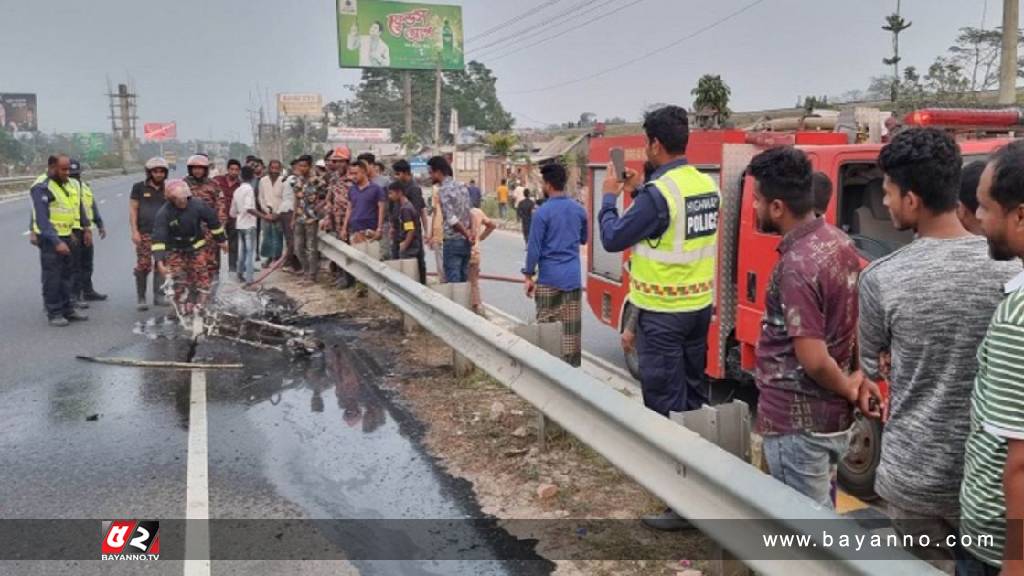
[153,180,227,315]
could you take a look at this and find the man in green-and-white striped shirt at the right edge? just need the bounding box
[956,140,1024,576]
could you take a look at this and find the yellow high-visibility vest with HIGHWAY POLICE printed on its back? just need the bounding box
[630,165,721,313]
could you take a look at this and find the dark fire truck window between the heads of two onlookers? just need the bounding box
[838,163,913,260]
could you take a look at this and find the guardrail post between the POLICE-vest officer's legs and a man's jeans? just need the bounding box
[670,400,751,576]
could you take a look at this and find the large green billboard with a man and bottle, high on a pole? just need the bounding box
[337,0,465,70]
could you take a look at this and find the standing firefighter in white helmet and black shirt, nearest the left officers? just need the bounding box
[128,157,170,311]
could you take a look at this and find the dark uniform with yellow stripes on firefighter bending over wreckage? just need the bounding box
[153,198,227,304]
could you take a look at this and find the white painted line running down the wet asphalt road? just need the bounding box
[184,370,210,576]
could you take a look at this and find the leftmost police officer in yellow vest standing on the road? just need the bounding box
[30,155,92,327]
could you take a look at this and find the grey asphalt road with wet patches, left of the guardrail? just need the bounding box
[0,177,552,574]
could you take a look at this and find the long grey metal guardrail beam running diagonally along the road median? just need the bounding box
[319,234,942,576]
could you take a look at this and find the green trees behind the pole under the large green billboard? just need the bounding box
[325,60,514,142]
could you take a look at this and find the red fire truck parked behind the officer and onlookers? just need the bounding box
[587,109,1024,497]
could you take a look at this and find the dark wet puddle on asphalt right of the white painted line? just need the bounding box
[197,321,554,575]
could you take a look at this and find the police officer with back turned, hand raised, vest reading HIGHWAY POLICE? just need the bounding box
[599,106,720,530]
